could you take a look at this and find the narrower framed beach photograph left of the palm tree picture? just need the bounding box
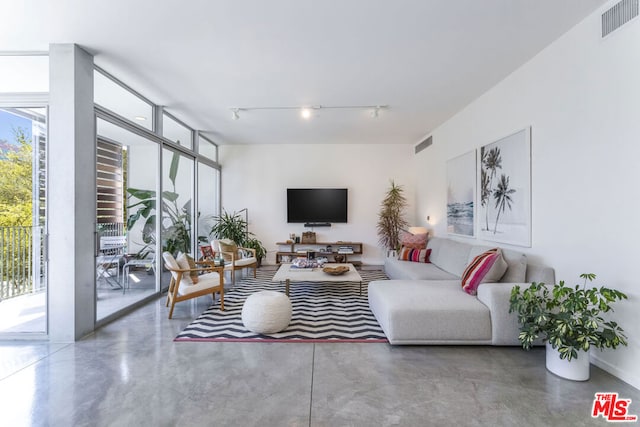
[447,150,476,237]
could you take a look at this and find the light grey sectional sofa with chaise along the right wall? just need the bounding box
[369,237,555,345]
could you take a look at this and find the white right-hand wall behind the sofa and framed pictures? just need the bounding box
[415,3,640,388]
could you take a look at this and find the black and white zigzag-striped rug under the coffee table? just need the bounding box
[175,270,387,342]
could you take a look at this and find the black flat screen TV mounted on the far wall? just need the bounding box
[287,188,347,223]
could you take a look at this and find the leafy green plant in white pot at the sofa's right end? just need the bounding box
[509,273,627,381]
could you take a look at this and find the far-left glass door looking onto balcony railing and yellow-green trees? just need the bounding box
[0,107,47,334]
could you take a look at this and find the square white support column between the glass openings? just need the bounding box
[47,44,96,342]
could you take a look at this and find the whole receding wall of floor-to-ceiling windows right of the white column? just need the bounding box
[94,69,220,322]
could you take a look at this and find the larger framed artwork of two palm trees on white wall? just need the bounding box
[477,127,531,247]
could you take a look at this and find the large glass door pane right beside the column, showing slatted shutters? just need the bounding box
[96,118,161,321]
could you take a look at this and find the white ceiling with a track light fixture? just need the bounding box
[0,0,605,144]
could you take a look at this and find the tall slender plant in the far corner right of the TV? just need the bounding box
[377,180,409,253]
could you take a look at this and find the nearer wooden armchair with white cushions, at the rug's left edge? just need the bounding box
[162,252,224,319]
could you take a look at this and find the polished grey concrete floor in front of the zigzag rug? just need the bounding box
[0,296,640,427]
